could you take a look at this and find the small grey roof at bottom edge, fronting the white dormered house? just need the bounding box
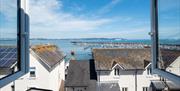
[100,83,120,91]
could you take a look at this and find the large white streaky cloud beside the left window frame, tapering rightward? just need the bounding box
[29,0,112,37]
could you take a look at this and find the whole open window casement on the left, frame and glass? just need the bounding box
[0,0,29,88]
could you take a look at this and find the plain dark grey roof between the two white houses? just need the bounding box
[65,60,96,91]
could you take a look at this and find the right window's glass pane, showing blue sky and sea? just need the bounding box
[157,0,180,76]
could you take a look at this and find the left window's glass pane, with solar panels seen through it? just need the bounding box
[0,0,18,79]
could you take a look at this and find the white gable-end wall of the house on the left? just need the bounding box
[15,54,50,91]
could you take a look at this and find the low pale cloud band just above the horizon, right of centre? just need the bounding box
[67,27,150,39]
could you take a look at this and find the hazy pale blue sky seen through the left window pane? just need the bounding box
[0,0,17,38]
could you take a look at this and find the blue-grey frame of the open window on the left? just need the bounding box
[0,0,29,88]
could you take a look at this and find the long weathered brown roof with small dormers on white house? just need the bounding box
[93,48,151,70]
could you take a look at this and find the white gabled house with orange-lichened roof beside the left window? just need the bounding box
[0,45,65,91]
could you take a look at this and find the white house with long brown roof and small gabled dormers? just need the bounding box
[93,49,159,91]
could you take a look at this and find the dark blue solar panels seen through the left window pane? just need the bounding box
[0,46,17,68]
